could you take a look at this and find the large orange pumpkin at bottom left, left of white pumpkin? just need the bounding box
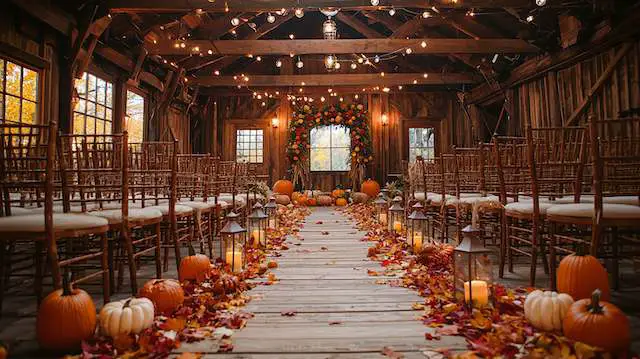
[36,275,97,351]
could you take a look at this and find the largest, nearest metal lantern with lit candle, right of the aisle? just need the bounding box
[453,225,493,309]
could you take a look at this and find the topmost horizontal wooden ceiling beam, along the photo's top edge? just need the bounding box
[108,0,540,13]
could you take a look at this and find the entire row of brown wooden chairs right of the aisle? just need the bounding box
[406,118,640,288]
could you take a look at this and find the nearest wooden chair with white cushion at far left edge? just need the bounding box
[0,122,110,312]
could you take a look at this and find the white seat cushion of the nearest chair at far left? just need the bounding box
[0,213,109,233]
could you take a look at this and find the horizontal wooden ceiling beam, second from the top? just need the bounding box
[147,39,538,56]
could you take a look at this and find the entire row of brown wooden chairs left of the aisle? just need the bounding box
[0,123,257,308]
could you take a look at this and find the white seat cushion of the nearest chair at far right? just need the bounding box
[547,203,640,220]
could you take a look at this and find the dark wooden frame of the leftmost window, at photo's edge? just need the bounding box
[0,52,42,125]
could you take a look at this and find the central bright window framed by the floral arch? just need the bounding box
[310,125,351,171]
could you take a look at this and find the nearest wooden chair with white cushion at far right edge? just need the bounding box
[547,118,640,289]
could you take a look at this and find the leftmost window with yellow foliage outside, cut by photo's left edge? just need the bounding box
[0,59,39,123]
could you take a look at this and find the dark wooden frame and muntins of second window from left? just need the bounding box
[69,71,115,135]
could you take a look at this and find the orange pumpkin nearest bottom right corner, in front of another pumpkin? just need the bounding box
[562,290,631,353]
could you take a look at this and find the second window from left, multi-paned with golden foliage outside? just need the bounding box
[73,72,113,135]
